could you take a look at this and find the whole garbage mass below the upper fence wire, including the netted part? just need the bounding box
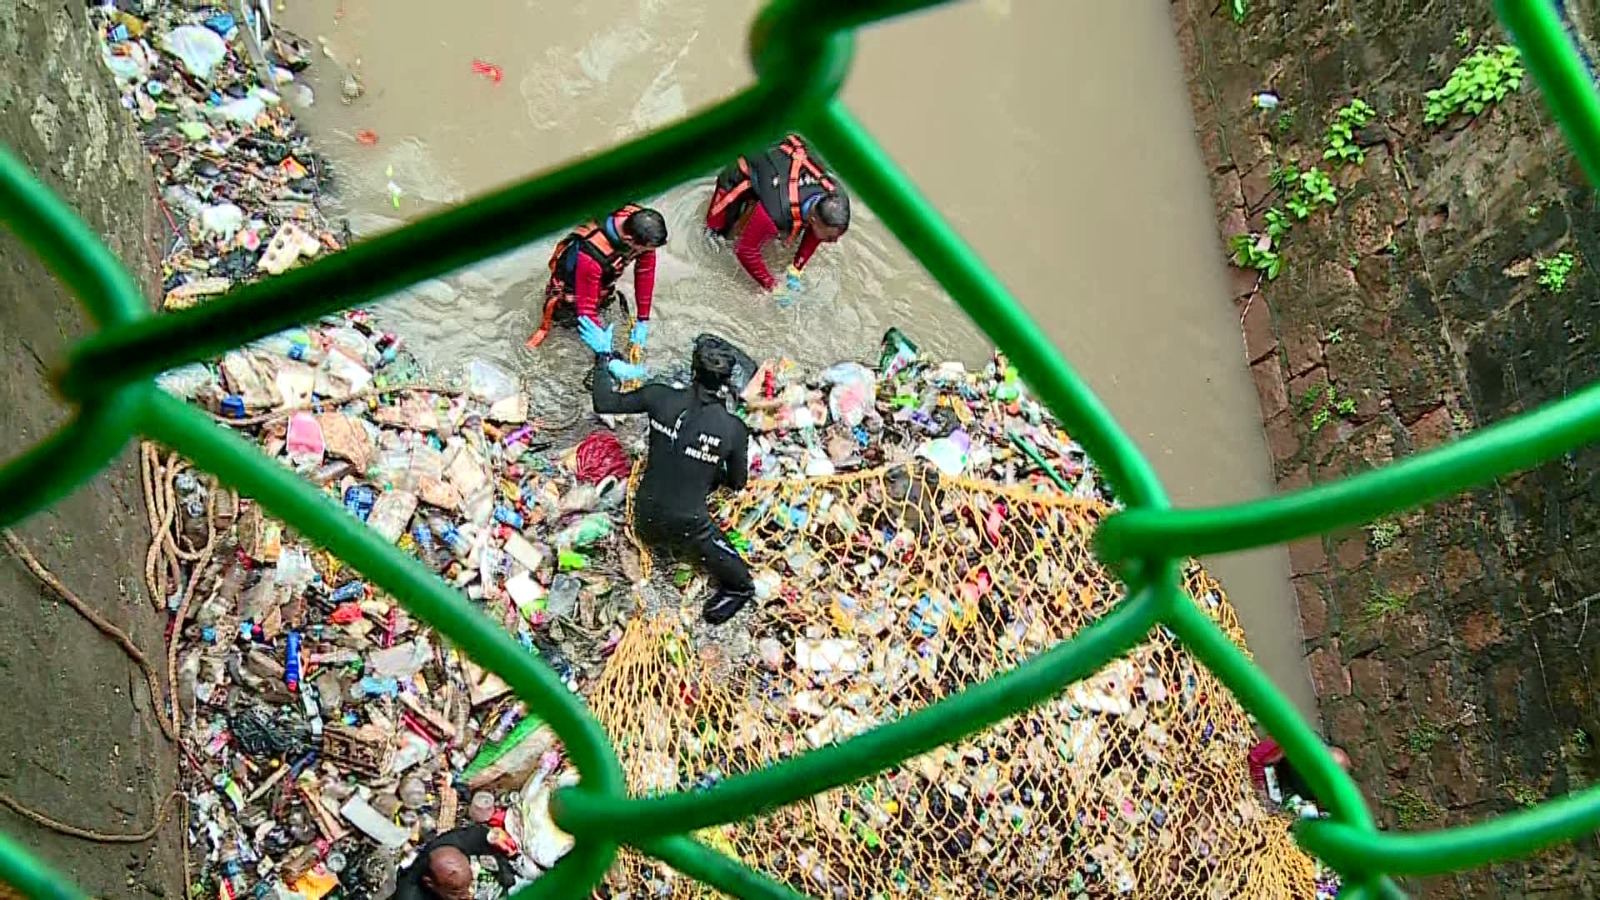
[144,312,1337,898]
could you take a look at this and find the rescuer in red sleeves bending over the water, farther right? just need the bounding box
[706,135,850,306]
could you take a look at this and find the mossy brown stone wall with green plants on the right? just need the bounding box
[1173,0,1600,898]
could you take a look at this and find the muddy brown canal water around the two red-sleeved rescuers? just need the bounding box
[278,0,1315,716]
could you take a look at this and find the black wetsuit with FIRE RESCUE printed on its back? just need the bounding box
[594,354,755,625]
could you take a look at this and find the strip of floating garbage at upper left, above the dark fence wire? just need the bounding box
[90,2,349,309]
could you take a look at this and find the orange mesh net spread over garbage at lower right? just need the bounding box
[589,466,1315,900]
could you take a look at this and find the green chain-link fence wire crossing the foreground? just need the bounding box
[0,0,1600,900]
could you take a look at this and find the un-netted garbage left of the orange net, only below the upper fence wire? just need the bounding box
[157,314,649,900]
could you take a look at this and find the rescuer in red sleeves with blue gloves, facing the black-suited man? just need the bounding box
[528,203,667,376]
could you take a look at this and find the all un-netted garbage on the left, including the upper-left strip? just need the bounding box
[91,3,629,900]
